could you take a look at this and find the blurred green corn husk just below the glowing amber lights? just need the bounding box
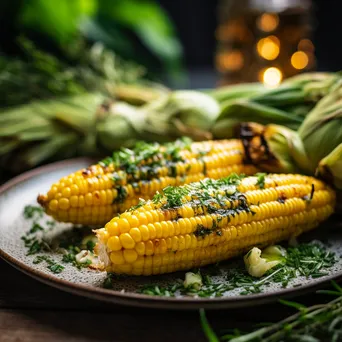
[212,73,340,139]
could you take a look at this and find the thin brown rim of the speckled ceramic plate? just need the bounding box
[0,157,342,310]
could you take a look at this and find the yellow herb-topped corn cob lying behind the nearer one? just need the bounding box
[38,139,256,225]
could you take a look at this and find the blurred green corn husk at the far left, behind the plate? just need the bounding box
[0,93,105,173]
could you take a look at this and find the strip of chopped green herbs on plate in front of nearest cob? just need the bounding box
[133,243,336,297]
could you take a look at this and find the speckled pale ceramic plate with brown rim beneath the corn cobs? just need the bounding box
[0,159,342,309]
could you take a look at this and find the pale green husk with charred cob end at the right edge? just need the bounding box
[241,82,342,189]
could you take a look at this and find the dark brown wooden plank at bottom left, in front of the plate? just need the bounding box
[0,310,206,342]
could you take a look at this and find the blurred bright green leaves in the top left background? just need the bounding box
[0,0,184,84]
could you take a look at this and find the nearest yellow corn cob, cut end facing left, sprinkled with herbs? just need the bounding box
[96,174,335,275]
